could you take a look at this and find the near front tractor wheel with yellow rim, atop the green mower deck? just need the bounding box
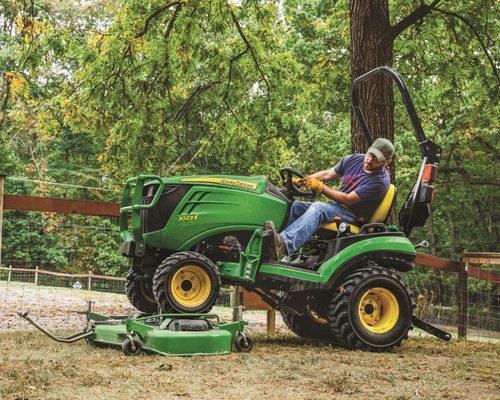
[153,251,221,313]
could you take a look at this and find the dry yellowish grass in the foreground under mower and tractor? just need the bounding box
[0,332,500,400]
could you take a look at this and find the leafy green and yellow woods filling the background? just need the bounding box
[0,0,500,273]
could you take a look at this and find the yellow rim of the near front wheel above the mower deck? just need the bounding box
[170,265,212,308]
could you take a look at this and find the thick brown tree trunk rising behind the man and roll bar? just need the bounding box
[350,0,394,153]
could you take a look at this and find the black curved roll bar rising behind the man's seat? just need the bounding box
[351,66,442,165]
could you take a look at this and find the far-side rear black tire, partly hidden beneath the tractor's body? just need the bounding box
[280,293,332,341]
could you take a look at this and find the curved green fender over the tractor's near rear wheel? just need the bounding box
[317,236,416,289]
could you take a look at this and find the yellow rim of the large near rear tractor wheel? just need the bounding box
[358,287,399,334]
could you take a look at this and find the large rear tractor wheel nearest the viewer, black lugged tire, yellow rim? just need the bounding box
[327,266,415,351]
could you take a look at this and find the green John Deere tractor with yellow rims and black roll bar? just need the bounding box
[120,67,449,351]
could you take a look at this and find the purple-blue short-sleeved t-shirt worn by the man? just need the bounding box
[333,154,391,218]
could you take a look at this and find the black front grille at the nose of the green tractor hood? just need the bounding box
[140,184,189,233]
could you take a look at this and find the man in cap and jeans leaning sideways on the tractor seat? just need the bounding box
[266,138,394,260]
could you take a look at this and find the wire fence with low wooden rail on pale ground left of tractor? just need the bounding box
[0,266,234,332]
